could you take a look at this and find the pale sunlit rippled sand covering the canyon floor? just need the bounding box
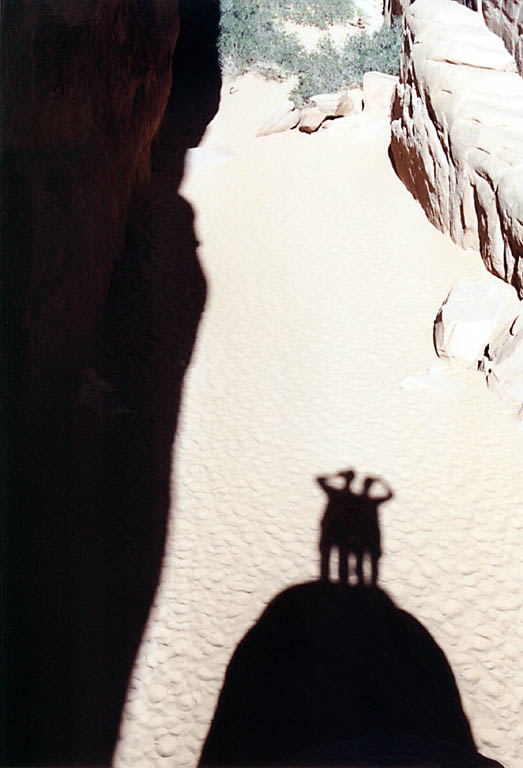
[116,76,523,768]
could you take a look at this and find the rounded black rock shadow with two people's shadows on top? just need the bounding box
[199,470,501,768]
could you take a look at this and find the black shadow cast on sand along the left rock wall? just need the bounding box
[5,0,221,766]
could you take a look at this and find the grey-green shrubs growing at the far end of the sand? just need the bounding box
[219,0,401,104]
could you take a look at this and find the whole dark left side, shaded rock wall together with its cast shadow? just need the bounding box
[0,0,220,766]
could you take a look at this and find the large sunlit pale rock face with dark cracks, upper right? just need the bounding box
[391,0,523,296]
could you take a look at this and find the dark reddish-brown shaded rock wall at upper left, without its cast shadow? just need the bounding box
[2,0,178,390]
